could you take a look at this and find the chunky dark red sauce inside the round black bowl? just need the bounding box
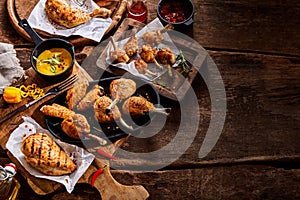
[159,1,191,23]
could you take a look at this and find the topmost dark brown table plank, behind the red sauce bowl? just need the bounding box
[0,0,300,56]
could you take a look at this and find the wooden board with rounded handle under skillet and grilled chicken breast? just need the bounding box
[0,62,149,200]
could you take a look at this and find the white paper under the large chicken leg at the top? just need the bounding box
[28,0,112,42]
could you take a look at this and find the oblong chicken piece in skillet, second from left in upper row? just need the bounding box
[77,85,104,111]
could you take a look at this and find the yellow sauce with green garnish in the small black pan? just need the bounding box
[35,48,72,75]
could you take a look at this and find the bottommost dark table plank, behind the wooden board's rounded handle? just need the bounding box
[14,165,300,200]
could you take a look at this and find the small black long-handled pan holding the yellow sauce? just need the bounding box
[19,19,75,82]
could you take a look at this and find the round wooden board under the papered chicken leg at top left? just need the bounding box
[6,0,130,46]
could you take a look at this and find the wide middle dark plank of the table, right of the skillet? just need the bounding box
[110,52,300,168]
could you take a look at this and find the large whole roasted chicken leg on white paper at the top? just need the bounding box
[45,0,111,28]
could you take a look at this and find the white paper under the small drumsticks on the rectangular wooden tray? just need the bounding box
[104,18,179,81]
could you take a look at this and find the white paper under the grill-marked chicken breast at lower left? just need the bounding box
[6,117,95,193]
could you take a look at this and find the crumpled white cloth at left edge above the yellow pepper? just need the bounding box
[0,42,25,94]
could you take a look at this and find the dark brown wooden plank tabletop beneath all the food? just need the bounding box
[0,0,300,199]
